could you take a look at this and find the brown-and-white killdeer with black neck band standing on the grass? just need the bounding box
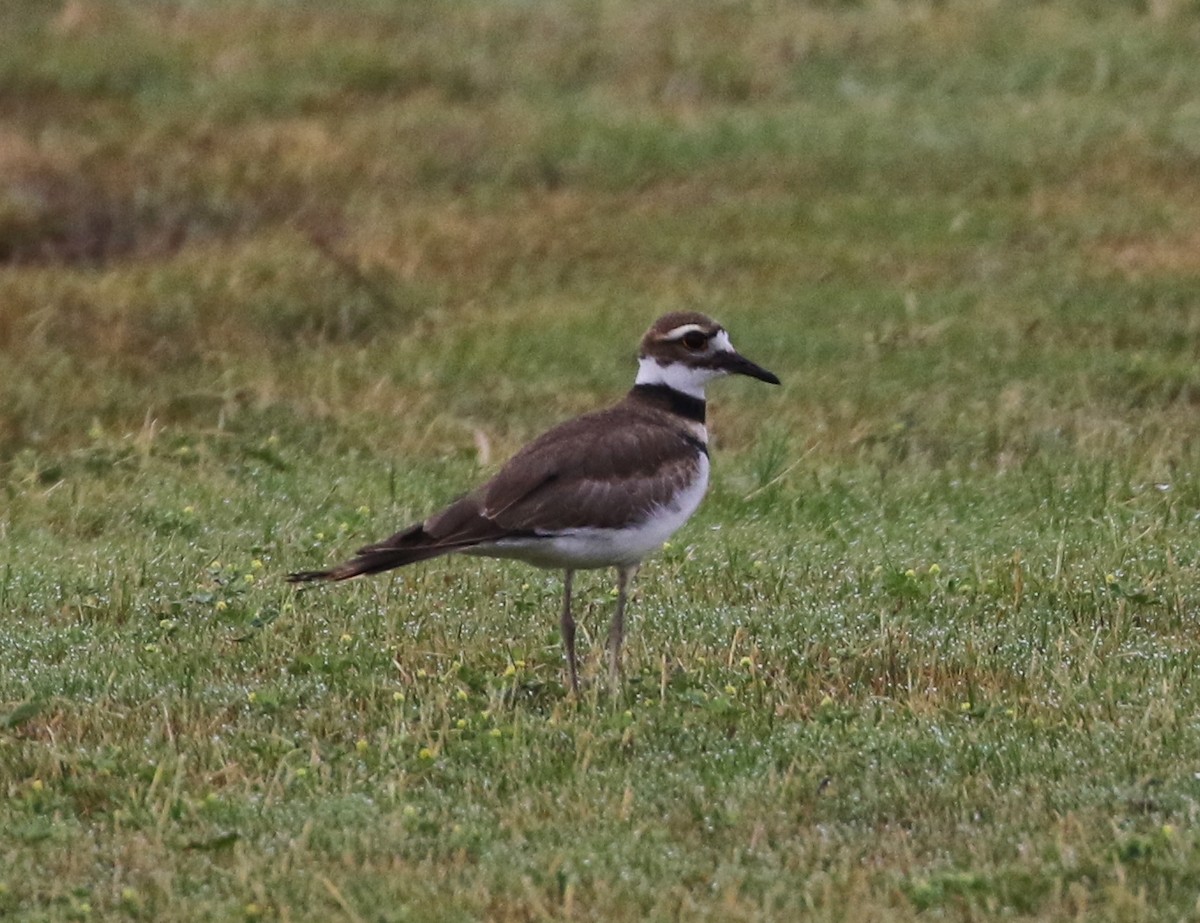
[288,311,779,694]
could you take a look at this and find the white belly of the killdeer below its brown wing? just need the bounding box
[467,455,708,570]
